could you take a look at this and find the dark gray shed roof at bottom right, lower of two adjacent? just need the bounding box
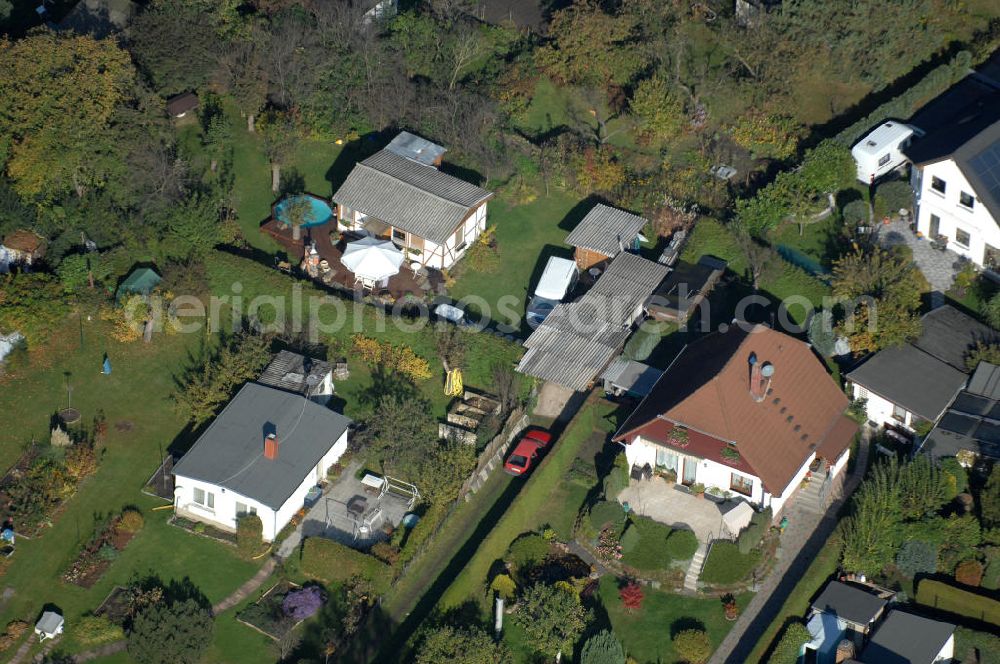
[861,609,955,664]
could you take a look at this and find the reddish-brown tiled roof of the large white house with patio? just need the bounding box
[615,324,857,494]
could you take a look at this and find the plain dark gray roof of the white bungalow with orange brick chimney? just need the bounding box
[174,383,351,509]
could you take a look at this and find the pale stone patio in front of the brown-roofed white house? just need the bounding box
[618,477,736,544]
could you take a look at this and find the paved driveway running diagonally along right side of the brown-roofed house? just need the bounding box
[709,428,870,664]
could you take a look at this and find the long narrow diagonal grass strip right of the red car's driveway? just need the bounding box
[440,401,613,609]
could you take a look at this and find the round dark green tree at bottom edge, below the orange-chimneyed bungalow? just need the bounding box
[128,599,212,664]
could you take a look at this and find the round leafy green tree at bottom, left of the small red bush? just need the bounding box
[514,583,589,658]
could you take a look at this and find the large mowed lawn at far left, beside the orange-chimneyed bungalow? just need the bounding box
[0,317,260,650]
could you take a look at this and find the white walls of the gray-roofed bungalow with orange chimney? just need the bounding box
[174,431,347,542]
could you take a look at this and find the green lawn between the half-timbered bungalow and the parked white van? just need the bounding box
[450,188,591,330]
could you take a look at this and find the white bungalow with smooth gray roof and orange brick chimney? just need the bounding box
[174,383,351,541]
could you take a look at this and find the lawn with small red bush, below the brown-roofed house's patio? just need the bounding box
[599,576,752,664]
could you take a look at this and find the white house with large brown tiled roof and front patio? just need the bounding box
[614,323,858,515]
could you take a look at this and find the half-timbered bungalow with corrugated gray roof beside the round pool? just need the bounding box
[333,132,493,270]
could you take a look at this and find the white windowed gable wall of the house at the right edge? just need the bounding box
[914,159,1000,267]
